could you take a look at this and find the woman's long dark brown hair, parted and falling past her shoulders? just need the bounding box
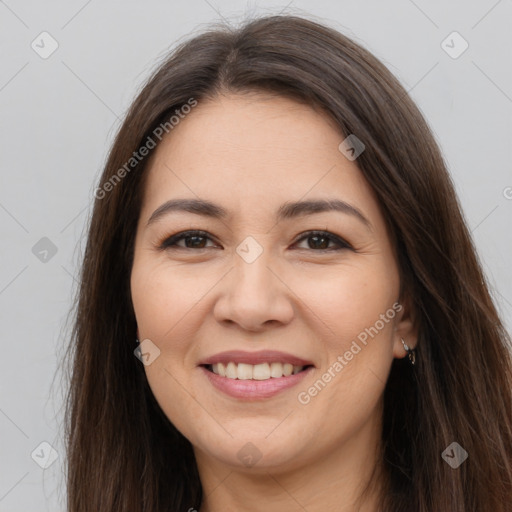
[66,15,512,512]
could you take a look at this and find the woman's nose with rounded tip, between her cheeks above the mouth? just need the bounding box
[214,251,294,332]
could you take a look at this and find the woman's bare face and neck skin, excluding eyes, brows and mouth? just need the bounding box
[131,93,417,512]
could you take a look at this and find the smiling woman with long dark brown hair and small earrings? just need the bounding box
[63,16,512,512]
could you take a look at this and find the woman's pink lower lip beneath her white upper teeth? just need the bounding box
[201,366,313,400]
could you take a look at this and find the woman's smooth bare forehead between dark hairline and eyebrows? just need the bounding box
[142,93,380,228]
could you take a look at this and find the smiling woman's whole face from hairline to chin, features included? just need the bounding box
[131,94,414,471]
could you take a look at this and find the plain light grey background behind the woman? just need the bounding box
[0,0,512,512]
